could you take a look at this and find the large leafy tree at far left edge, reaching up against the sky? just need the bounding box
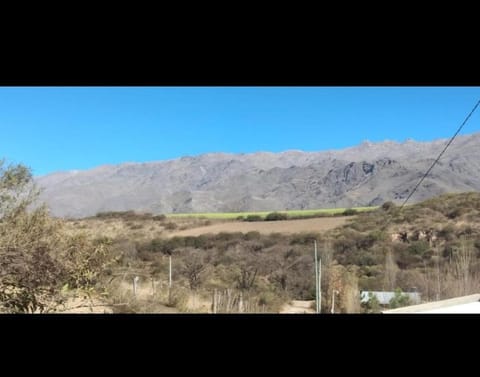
[0,161,116,313]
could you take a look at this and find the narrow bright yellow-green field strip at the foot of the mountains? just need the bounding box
[166,207,378,220]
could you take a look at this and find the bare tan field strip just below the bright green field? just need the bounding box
[169,217,351,237]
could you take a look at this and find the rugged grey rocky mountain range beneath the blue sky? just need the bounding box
[35,133,480,218]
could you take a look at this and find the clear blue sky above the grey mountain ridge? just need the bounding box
[0,87,480,175]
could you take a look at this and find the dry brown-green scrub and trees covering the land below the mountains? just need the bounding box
[0,158,480,313]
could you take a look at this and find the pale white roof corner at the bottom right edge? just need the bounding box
[383,294,480,314]
